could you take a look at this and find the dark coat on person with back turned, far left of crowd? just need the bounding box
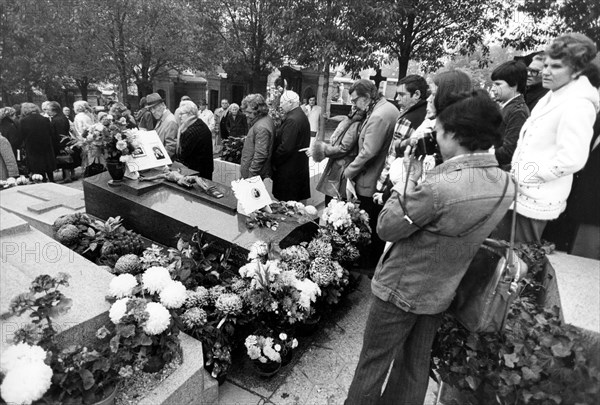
[21,113,56,174]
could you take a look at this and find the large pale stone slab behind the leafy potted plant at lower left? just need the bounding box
[0,208,113,352]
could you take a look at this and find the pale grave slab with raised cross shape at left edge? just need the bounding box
[0,183,85,237]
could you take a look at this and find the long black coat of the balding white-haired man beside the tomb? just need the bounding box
[271,107,310,201]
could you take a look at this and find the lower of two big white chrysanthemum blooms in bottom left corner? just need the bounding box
[0,362,52,404]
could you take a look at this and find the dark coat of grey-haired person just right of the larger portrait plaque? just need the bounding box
[179,119,214,180]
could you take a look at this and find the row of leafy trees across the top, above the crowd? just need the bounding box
[0,0,600,104]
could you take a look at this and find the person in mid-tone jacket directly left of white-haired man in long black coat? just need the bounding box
[240,94,275,179]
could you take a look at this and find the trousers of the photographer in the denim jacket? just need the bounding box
[345,297,442,405]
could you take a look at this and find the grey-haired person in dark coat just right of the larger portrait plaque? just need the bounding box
[176,100,214,180]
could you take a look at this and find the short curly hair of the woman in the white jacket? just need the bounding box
[546,32,598,72]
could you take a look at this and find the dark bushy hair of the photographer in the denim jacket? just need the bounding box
[437,89,502,151]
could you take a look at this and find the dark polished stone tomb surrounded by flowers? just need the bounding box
[83,173,316,263]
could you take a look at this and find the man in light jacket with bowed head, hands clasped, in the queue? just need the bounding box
[344,79,399,268]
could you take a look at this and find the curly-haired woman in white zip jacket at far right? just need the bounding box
[494,33,599,242]
